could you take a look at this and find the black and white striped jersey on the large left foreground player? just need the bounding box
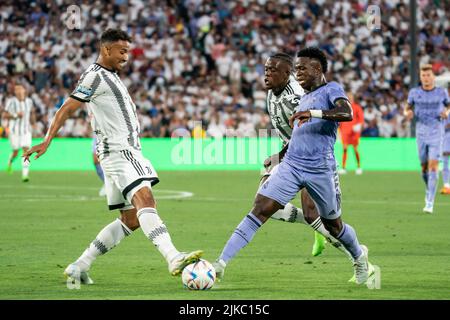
[70,63,141,155]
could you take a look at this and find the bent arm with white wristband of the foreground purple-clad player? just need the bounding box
[289,98,353,127]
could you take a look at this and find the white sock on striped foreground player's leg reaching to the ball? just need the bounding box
[137,208,180,262]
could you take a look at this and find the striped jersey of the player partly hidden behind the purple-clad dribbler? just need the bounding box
[267,76,305,143]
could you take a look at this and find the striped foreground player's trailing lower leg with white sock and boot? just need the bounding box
[64,218,133,284]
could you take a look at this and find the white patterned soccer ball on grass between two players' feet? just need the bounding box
[181,259,216,290]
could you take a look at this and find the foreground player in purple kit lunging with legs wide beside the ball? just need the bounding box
[213,47,374,284]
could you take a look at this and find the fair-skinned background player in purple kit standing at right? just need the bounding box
[405,64,450,213]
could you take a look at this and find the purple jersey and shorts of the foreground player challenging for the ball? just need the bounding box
[258,82,347,219]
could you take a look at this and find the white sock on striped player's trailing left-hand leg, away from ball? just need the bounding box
[76,219,133,271]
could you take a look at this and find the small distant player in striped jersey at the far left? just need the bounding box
[5,84,34,182]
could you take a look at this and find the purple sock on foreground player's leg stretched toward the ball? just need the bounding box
[219,212,262,263]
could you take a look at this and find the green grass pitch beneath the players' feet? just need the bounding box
[0,171,450,299]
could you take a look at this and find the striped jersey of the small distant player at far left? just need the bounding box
[5,97,33,136]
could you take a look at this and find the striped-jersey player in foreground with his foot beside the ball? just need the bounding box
[25,29,203,284]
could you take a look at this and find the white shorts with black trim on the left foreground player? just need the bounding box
[100,150,159,210]
